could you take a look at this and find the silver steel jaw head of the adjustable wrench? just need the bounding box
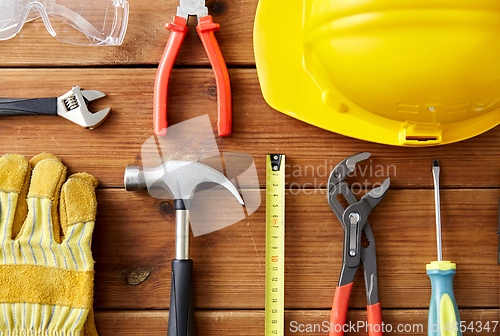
[57,86,111,129]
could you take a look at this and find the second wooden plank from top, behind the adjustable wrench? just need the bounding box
[0,68,500,189]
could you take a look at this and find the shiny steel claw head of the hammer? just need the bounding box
[124,161,244,205]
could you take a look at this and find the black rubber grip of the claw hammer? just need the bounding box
[167,259,196,336]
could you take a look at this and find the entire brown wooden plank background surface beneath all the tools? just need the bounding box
[0,0,500,336]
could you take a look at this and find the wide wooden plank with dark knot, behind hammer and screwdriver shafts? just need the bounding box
[93,189,500,309]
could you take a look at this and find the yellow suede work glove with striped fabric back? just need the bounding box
[0,154,97,336]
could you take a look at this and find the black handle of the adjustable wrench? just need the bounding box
[0,97,57,117]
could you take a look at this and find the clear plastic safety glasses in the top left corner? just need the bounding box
[0,0,129,46]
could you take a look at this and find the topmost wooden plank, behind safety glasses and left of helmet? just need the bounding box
[0,0,257,67]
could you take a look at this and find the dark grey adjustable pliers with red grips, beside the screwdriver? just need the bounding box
[328,152,390,336]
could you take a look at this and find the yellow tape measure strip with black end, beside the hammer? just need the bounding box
[265,154,285,336]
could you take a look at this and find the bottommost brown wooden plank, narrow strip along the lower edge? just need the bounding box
[96,309,499,336]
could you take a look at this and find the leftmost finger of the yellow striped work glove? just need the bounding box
[0,154,31,241]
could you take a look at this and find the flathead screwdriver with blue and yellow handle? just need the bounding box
[425,160,462,336]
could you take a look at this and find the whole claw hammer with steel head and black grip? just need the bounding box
[124,161,244,336]
